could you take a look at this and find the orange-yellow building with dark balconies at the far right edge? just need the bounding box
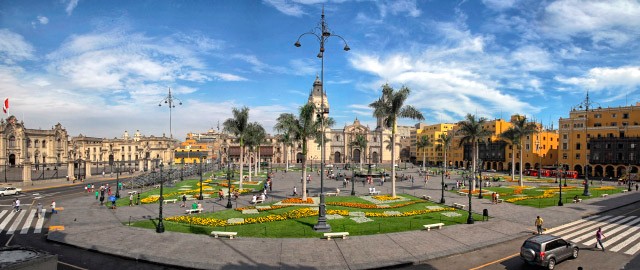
[559,100,640,178]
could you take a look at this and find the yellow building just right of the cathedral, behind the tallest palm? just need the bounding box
[411,123,456,166]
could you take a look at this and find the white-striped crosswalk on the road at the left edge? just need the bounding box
[0,209,46,235]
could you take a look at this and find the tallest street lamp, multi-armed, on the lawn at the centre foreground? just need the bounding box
[294,7,351,232]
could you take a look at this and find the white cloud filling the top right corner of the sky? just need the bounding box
[541,0,640,47]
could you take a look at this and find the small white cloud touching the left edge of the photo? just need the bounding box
[0,29,34,64]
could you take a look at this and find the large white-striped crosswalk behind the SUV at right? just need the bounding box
[545,215,640,255]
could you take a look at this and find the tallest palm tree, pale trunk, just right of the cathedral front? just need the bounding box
[369,84,424,198]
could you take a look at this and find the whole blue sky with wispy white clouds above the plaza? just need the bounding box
[0,0,640,139]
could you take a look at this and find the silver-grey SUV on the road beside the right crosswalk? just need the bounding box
[520,234,579,270]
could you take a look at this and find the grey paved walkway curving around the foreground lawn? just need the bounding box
[48,168,640,269]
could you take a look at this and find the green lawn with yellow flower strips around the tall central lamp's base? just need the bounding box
[127,195,482,238]
